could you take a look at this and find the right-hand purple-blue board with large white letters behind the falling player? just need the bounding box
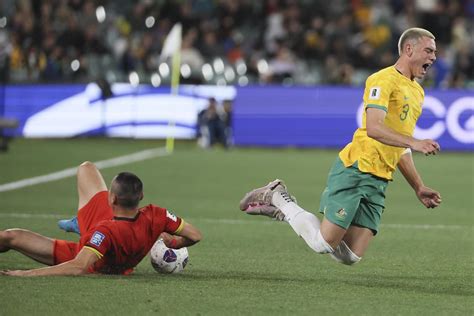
[234,87,474,150]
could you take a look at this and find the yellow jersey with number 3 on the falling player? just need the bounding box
[339,66,425,180]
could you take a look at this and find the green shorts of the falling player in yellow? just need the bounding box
[319,157,388,235]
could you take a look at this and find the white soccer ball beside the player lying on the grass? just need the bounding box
[150,239,189,273]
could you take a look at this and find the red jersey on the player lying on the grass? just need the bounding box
[79,204,184,274]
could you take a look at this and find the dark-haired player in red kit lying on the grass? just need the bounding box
[0,162,201,276]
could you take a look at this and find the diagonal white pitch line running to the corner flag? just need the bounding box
[0,148,169,192]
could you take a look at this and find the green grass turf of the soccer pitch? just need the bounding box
[0,139,474,315]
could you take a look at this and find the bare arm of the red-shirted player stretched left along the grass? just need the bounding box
[0,248,99,276]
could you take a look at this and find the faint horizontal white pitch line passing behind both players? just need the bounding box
[0,211,474,230]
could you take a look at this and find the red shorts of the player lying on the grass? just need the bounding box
[53,191,114,264]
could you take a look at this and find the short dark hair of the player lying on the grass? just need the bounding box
[110,172,143,209]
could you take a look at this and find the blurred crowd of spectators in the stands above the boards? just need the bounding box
[0,0,474,89]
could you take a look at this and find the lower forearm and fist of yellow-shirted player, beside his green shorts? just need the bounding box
[398,151,441,208]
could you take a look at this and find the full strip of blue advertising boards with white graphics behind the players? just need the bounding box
[0,84,474,151]
